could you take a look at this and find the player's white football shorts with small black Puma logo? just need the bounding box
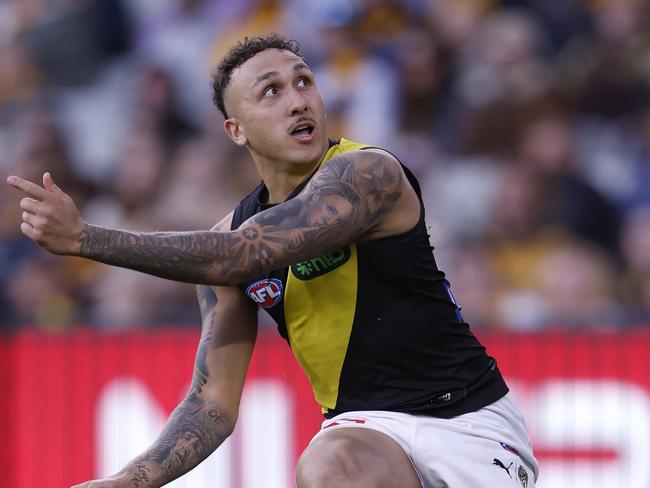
[312,394,539,488]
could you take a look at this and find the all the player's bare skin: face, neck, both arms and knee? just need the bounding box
[8,49,420,488]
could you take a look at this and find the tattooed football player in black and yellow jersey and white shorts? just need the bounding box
[8,35,537,488]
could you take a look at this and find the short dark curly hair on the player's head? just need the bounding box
[212,32,304,119]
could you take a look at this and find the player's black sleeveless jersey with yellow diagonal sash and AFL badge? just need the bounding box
[232,139,508,418]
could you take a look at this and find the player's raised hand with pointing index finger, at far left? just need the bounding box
[7,173,87,254]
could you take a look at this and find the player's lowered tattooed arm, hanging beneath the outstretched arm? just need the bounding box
[73,285,257,488]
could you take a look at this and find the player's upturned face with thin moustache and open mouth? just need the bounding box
[225,49,327,167]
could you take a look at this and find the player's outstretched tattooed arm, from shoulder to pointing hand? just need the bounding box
[10,151,419,285]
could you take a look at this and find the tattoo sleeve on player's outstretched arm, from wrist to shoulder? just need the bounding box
[80,151,402,285]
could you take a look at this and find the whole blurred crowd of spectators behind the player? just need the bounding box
[0,0,650,330]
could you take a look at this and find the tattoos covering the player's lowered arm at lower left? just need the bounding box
[119,285,234,488]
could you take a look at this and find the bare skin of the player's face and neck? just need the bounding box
[224,49,328,203]
